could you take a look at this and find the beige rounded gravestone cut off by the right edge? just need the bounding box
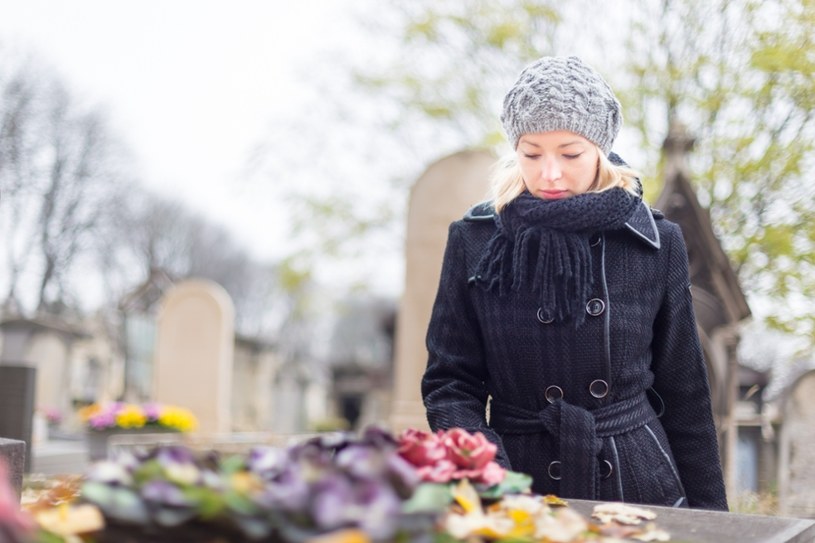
[778,370,815,518]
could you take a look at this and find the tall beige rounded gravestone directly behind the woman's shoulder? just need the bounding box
[391,150,495,431]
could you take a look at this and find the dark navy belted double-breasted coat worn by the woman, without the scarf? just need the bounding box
[422,200,727,510]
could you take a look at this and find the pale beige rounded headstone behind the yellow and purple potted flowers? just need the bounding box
[153,279,235,433]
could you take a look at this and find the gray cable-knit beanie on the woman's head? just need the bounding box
[501,57,623,155]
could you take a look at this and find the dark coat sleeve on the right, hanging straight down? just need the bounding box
[652,223,727,510]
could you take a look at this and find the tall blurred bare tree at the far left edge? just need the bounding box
[0,52,127,310]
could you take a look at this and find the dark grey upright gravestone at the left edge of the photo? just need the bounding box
[0,363,37,471]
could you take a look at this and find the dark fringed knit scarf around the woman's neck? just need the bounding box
[476,188,641,326]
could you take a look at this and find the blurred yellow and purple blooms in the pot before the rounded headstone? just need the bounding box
[79,402,198,432]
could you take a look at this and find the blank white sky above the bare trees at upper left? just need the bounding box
[0,0,353,264]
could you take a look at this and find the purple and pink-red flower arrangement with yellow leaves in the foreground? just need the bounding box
[22,428,668,543]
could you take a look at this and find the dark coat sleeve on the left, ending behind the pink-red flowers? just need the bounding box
[422,222,511,469]
